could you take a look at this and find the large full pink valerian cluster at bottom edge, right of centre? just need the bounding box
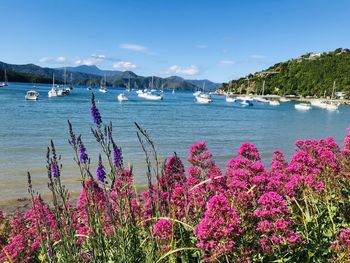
[194,194,242,261]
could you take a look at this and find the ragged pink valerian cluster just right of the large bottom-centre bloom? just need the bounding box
[254,192,301,253]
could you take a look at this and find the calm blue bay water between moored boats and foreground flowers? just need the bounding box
[0,83,350,205]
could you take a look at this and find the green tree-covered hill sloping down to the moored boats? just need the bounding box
[220,48,350,97]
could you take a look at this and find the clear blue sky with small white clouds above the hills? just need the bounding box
[0,0,350,82]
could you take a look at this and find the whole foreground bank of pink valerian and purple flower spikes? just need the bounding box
[0,96,350,262]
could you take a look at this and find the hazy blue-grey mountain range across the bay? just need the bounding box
[0,62,221,91]
